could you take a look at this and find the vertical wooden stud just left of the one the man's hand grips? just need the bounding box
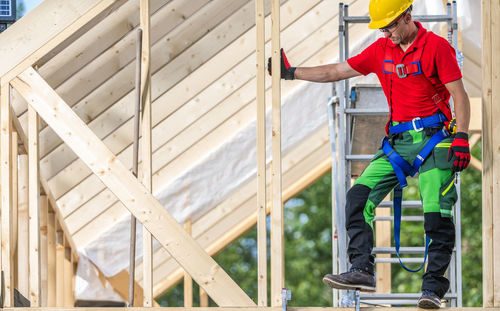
[255,0,267,307]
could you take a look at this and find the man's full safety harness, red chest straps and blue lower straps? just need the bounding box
[382,32,452,272]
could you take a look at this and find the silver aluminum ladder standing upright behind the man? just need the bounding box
[328,1,462,309]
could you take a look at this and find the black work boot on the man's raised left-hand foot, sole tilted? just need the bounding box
[323,268,376,292]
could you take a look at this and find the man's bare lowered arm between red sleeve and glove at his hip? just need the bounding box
[445,79,470,134]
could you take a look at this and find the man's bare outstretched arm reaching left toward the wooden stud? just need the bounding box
[295,62,361,82]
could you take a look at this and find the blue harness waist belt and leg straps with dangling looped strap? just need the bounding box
[382,114,450,272]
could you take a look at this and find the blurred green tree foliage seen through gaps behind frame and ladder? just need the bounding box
[159,144,482,307]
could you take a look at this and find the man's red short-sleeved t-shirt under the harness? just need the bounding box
[347,22,462,122]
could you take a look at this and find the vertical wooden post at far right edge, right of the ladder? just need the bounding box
[481,0,499,307]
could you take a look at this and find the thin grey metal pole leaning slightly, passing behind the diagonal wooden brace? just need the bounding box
[128,28,142,307]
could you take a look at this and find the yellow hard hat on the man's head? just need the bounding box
[368,0,413,29]
